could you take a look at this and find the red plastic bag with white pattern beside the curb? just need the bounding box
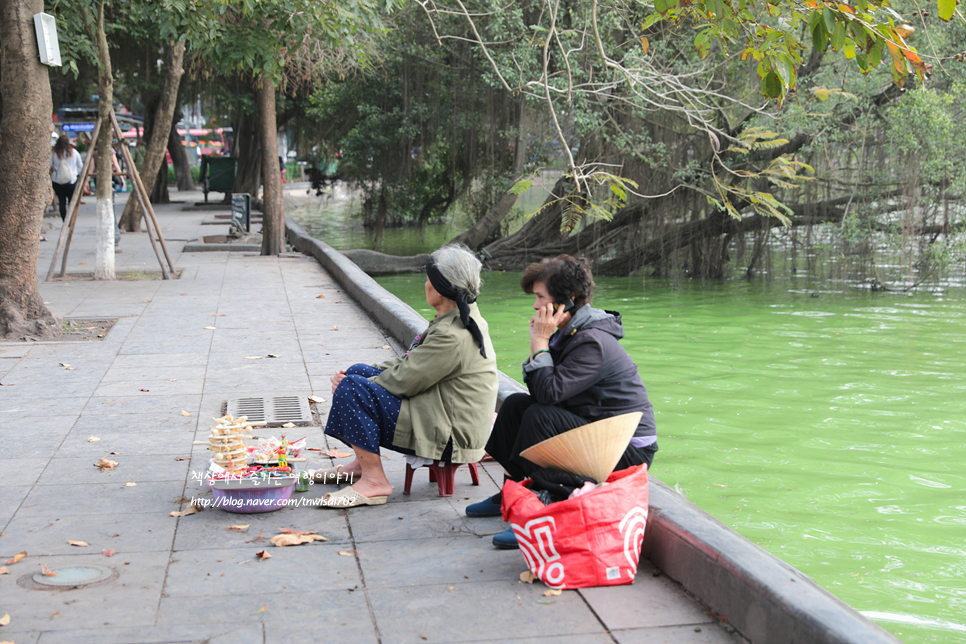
[503,465,647,588]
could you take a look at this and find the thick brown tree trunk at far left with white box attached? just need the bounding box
[0,0,57,340]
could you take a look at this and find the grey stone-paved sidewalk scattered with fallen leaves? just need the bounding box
[0,192,742,644]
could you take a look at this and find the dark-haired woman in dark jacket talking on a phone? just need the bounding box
[466,255,657,549]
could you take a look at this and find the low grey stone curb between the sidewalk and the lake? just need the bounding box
[285,216,899,644]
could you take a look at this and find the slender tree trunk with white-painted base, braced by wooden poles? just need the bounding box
[94,0,116,280]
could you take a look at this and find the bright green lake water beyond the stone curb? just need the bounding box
[294,199,966,644]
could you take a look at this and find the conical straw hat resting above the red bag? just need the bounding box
[520,411,643,483]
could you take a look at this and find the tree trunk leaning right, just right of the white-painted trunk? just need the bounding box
[121,41,185,232]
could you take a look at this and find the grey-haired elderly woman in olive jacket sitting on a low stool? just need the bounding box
[312,246,497,508]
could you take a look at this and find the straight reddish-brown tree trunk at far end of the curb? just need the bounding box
[255,77,285,255]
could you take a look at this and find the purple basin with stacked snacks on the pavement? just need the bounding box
[208,416,305,514]
